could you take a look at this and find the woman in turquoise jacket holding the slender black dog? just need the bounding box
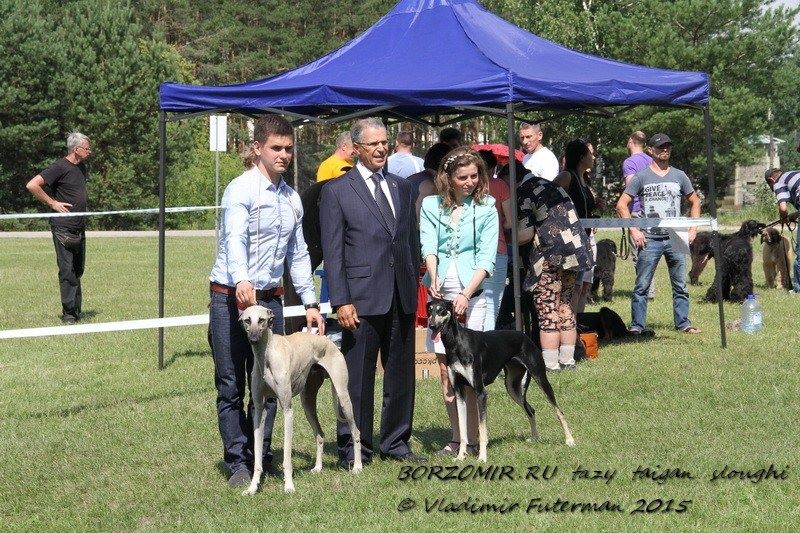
[419,147,500,455]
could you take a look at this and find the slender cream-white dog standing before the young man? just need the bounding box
[239,305,362,495]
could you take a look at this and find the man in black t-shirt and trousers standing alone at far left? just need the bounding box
[26,132,92,324]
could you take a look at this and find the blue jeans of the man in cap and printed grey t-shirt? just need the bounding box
[631,237,692,331]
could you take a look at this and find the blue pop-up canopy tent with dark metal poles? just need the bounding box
[159,0,725,366]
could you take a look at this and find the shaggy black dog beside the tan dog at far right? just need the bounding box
[704,220,766,303]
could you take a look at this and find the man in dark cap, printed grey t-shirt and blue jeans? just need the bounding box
[617,133,700,333]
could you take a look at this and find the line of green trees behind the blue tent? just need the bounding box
[0,0,800,229]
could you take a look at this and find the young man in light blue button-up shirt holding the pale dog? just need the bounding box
[209,115,325,487]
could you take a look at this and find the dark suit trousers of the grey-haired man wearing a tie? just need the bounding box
[337,289,415,461]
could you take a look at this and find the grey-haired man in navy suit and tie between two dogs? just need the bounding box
[320,118,425,468]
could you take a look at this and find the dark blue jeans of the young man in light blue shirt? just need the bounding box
[209,292,283,473]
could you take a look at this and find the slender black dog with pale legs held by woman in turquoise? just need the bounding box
[428,300,575,462]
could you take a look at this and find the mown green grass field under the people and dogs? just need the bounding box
[0,233,800,531]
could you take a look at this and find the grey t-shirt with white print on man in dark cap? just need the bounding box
[625,166,694,239]
